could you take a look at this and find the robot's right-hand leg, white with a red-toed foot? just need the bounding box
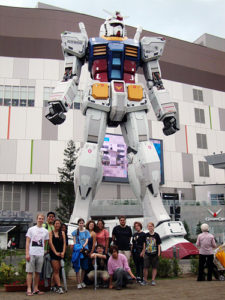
[122,111,195,258]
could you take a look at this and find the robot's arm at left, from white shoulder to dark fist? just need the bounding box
[45,23,88,125]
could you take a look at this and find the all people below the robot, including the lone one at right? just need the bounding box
[26,212,216,296]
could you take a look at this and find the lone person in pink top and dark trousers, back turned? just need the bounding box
[196,224,217,281]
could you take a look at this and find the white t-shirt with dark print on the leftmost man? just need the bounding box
[26,225,49,256]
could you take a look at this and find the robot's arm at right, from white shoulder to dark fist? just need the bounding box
[141,37,179,135]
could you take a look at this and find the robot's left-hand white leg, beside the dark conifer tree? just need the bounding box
[70,108,107,223]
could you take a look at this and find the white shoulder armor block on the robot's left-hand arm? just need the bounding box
[61,31,88,58]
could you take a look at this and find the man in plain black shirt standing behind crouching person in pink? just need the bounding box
[112,216,132,263]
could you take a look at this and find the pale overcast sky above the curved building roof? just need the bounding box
[0,0,225,42]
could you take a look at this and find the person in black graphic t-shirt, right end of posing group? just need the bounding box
[144,222,161,286]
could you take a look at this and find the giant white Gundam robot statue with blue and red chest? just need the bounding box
[46,12,198,255]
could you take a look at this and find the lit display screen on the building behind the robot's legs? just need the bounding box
[101,134,164,184]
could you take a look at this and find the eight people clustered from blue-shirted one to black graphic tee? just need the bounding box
[72,216,161,290]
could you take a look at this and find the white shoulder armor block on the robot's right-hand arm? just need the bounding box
[141,37,165,62]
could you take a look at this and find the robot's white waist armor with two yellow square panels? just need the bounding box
[83,80,148,122]
